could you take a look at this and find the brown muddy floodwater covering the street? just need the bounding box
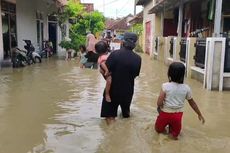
[0,55,230,153]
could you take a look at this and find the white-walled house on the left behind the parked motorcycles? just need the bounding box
[0,0,68,66]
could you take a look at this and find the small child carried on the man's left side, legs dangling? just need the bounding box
[95,41,112,102]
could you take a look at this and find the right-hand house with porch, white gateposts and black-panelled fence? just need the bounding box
[136,0,230,90]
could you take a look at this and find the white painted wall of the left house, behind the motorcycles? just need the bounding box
[16,0,61,54]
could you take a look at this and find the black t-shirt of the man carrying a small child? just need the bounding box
[106,48,141,97]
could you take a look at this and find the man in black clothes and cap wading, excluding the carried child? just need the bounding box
[101,33,141,124]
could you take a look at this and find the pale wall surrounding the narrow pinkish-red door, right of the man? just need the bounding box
[143,0,155,56]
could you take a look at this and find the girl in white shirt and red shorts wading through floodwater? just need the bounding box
[155,62,205,140]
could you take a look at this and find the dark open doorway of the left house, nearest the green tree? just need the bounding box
[49,22,57,53]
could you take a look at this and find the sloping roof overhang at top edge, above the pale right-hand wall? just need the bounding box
[149,0,180,14]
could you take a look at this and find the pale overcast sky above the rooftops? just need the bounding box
[81,0,142,18]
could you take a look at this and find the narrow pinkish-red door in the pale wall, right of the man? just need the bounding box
[145,21,151,54]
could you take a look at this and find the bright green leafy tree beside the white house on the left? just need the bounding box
[59,0,105,51]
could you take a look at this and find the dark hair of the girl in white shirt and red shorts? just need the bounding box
[168,62,185,83]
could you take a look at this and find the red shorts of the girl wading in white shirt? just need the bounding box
[155,111,183,137]
